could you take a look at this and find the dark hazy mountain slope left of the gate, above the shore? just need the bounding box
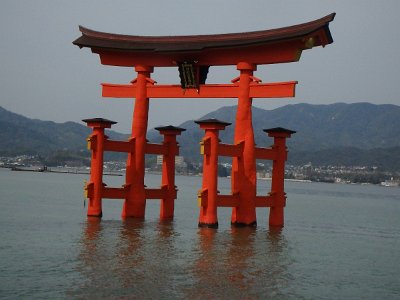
[0,106,126,156]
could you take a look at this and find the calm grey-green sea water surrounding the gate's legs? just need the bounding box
[0,169,400,299]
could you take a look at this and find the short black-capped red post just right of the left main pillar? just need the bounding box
[155,126,186,219]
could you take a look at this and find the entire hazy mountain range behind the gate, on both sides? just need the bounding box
[0,103,400,170]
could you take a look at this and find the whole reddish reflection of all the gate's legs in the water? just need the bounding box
[70,219,292,299]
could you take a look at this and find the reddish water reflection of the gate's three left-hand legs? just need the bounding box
[71,219,180,299]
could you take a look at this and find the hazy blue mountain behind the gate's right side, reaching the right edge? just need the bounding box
[149,103,400,162]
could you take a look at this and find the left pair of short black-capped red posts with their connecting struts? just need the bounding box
[84,119,184,219]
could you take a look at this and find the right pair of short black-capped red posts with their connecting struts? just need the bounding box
[196,119,295,227]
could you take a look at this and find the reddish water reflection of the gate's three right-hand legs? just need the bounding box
[186,227,292,299]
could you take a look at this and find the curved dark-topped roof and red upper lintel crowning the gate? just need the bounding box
[73,13,335,66]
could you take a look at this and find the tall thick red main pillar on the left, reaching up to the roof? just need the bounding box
[122,66,153,218]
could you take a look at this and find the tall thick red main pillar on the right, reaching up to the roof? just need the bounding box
[232,62,257,226]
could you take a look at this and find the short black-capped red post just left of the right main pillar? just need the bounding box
[196,119,231,227]
